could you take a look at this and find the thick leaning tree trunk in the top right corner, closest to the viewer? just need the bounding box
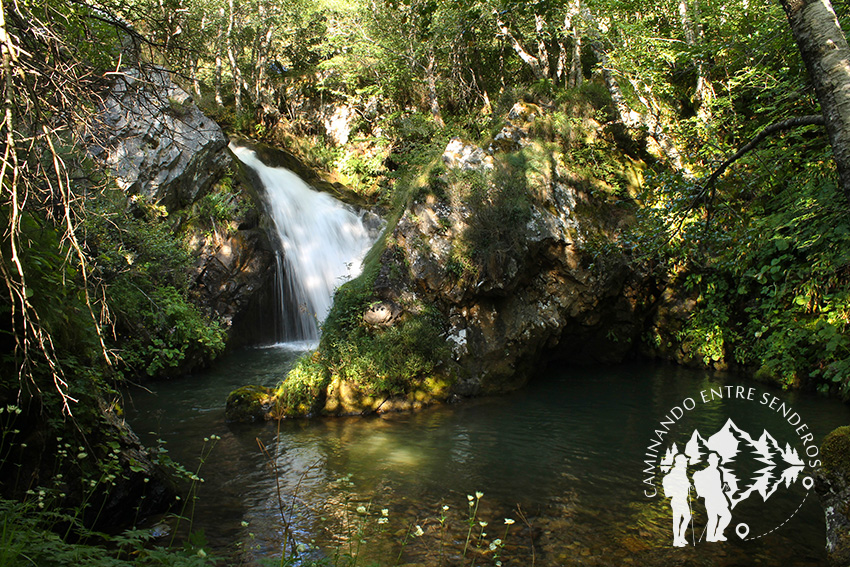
[780,0,850,201]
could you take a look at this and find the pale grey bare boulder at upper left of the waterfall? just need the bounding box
[90,67,232,211]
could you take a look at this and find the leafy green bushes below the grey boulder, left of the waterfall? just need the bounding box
[86,195,229,382]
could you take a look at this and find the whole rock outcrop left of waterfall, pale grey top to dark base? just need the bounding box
[89,67,276,350]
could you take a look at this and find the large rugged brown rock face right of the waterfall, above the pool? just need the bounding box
[375,135,647,395]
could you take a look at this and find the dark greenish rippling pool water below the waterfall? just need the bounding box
[128,348,850,565]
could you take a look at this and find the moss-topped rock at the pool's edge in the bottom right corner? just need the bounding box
[815,426,850,567]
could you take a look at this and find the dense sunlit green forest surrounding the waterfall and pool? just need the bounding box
[0,0,850,565]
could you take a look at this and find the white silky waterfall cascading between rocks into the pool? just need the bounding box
[230,144,376,343]
